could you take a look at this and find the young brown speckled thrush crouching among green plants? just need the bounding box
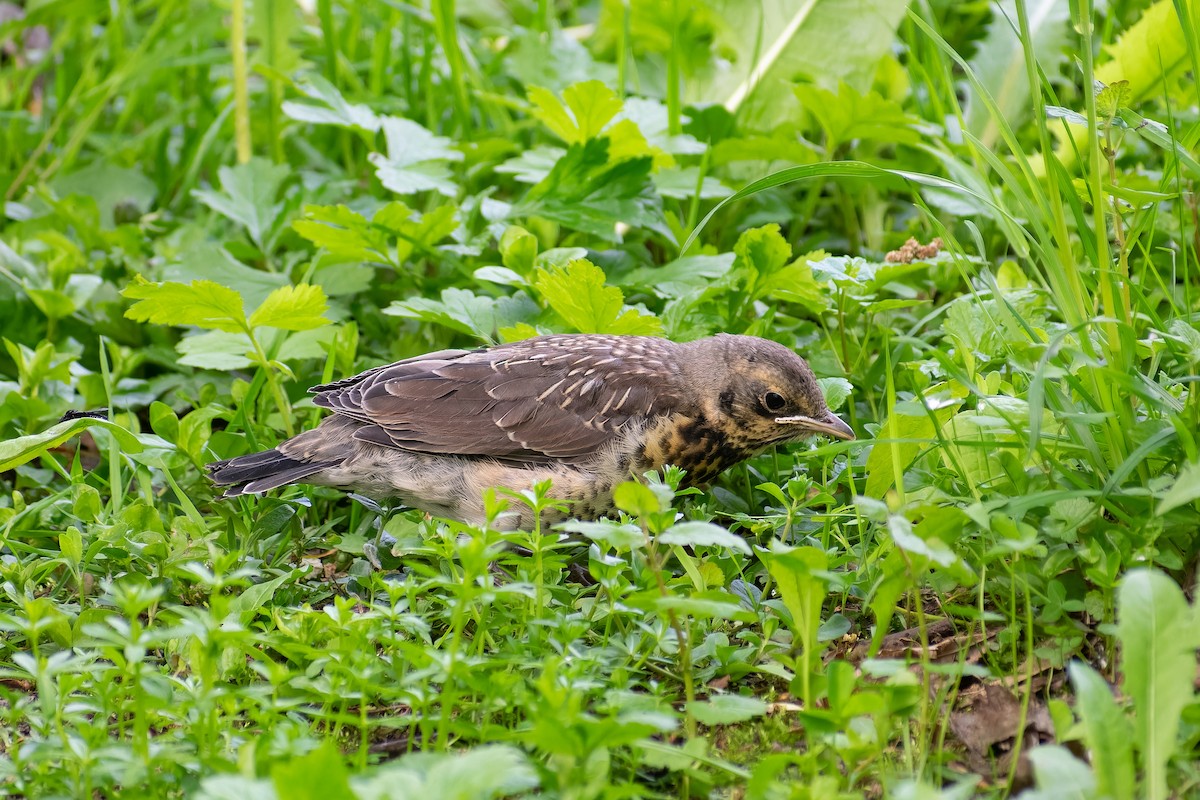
[208,333,854,530]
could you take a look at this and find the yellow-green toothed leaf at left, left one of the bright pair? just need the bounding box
[121,276,248,333]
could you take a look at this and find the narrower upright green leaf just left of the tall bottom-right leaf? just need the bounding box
[1067,661,1135,800]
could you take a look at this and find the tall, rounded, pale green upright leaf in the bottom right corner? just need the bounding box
[1117,569,1200,800]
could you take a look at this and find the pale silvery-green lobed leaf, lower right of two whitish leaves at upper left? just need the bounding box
[371,116,463,197]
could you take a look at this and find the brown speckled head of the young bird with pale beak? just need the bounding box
[689,333,854,450]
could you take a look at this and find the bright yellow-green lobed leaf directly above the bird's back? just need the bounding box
[534,258,662,336]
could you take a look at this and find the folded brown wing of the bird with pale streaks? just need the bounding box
[313,336,684,462]
